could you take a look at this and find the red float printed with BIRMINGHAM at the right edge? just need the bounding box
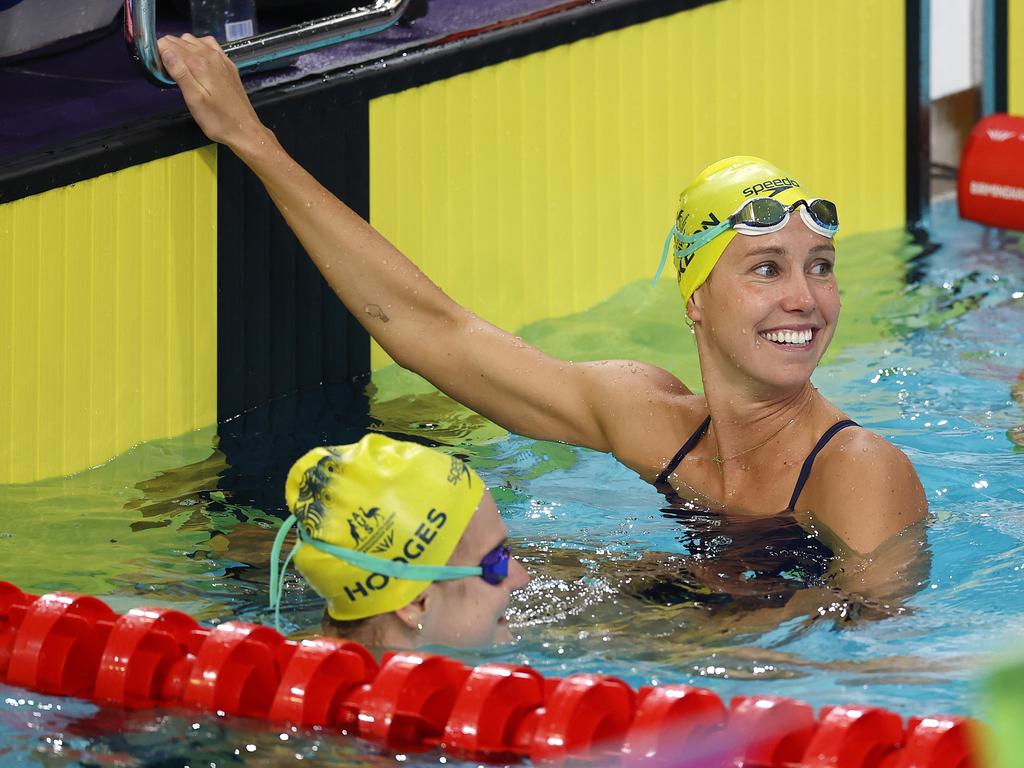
[956,115,1024,230]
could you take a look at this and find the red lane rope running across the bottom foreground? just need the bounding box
[0,582,980,768]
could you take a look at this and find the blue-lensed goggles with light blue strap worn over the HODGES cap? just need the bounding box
[270,515,512,627]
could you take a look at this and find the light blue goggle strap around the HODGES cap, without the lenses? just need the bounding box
[270,515,483,631]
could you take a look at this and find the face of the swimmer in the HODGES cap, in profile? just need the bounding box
[420,490,529,647]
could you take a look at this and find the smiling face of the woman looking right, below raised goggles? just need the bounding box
[687,216,840,387]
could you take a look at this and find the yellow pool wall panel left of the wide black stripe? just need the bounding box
[0,146,217,483]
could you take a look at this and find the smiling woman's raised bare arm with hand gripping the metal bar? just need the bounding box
[159,35,687,452]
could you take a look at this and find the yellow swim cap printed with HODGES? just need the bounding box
[285,434,484,621]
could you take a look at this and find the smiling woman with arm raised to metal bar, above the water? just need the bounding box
[159,36,927,553]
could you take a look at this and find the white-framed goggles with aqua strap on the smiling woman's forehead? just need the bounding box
[654,198,839,282]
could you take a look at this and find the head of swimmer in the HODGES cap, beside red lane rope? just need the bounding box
[270,434,529,648]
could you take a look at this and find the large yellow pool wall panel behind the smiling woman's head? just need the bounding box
[370,0,905,369]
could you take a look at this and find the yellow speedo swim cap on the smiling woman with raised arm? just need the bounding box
[671,155,811,301]
